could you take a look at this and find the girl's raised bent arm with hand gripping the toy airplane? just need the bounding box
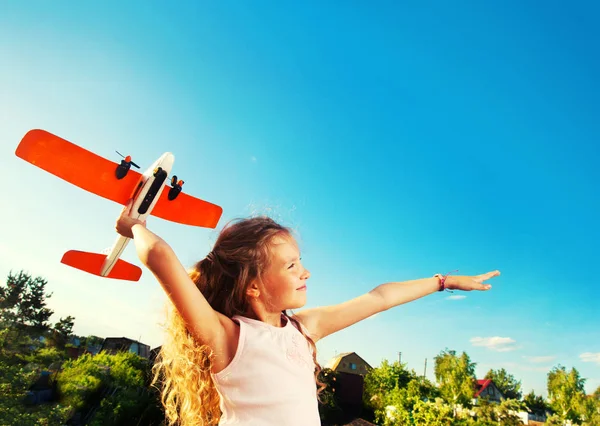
[116,203,237,370]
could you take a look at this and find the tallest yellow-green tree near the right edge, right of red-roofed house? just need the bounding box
[548,365,585,422]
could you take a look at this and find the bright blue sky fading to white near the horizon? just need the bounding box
[0,1,600,394]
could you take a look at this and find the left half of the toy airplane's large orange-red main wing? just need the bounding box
[15,129,141,205]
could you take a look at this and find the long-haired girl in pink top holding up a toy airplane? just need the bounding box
[116,203,499,426]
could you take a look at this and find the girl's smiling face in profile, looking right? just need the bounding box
[261,235,310,312]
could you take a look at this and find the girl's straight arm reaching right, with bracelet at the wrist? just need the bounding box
[296,271,500,341]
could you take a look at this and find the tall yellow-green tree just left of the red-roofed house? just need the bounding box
[434,349,476,406]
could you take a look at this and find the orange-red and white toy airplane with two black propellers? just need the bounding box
[15,129,223,281]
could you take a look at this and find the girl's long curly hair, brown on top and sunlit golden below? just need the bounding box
[152,217,325,426]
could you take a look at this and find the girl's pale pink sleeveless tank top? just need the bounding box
[212,315,321,426]
